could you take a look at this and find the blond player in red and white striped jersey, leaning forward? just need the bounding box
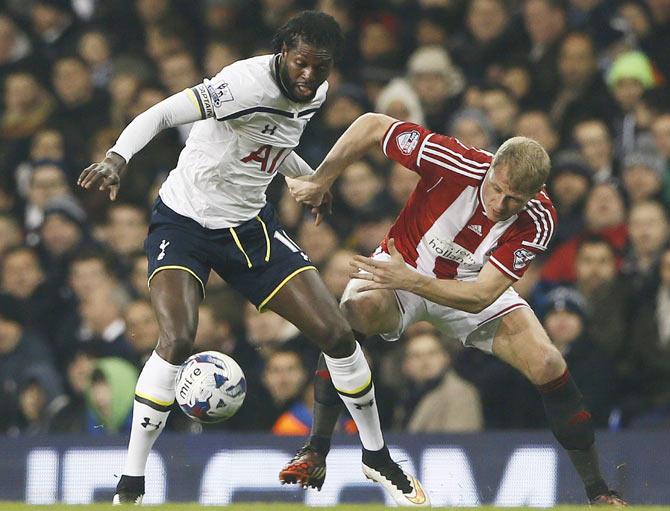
[280,114,626,505]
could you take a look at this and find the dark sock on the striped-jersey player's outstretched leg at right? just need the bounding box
[538,369,608,499]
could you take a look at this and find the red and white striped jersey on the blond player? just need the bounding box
[382,122,556,280]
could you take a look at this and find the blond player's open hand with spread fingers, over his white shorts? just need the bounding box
[349,239,417,291]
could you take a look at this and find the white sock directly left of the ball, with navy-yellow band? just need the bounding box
[123,351,179,476]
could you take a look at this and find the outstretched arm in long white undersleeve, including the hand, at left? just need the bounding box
[77,90,202,200]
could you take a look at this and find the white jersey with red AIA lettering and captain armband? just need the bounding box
[160,55,328,229]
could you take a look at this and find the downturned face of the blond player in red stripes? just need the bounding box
[482,165,535,222]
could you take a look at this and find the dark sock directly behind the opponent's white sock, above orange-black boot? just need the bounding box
[309,353,342,456]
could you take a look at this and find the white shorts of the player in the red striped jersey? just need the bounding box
[373,252,530,353]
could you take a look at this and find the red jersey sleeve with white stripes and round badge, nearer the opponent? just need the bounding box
[382,121,493,186]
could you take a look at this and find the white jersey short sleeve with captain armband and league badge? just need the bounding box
[192,62,259,121]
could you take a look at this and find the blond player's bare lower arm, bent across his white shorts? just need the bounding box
[350,239,513,313]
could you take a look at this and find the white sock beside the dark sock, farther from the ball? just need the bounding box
[324,343,384,451]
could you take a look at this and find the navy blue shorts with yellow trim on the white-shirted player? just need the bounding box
[144,197,316,310]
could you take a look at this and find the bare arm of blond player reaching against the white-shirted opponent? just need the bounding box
[287,113,397,206]
